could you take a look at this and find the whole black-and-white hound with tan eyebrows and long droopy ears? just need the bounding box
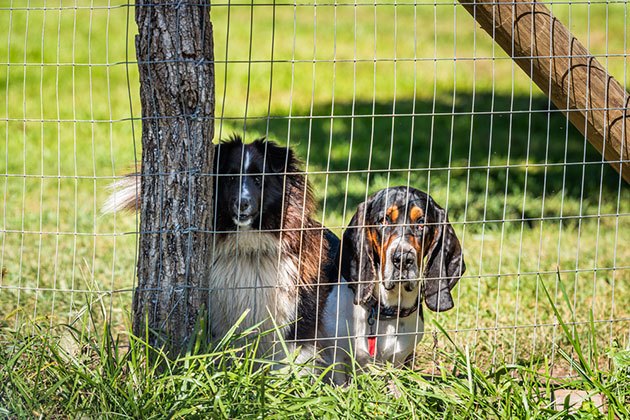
[323,187,466,383]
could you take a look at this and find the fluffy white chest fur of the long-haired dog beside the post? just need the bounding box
[209,231,298,341]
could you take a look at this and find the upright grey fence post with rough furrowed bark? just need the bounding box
[133,0,214,354]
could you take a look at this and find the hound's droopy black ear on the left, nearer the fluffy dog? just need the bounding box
[341,203,377,305]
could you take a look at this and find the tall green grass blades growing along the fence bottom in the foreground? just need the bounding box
[0,276,630,419]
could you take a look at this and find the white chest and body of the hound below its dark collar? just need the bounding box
[323,281,424,383]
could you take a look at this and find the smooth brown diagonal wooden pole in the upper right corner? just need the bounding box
[459,0,630,182]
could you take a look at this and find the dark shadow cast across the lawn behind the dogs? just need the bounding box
[247,93,627,224]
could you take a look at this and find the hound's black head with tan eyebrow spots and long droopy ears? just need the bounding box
[341,187,466,311]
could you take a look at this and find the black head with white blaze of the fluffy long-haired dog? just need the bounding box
[214,136,298,231]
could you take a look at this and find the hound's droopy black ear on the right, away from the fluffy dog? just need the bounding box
[424,200,466,312]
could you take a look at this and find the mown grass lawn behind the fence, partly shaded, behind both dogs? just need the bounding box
[0,0,630,416]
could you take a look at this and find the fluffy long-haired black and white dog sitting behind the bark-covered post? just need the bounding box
[104,137,339,360]
